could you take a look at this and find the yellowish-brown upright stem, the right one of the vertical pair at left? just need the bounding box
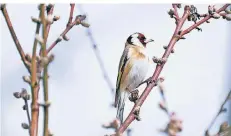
[41,4,49,136]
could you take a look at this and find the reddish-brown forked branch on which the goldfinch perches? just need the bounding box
[117,4,229,134]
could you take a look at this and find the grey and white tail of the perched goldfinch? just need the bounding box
[116,91,128,124]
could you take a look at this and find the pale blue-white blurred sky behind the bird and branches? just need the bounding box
[1,4,231,136]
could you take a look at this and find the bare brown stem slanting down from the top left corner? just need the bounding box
[1,4,30,73]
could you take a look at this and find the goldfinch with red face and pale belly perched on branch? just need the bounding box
[115,32,154,123]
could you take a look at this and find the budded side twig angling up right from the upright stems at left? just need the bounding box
[47,4,77,53]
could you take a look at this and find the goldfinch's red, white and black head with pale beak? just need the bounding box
[127,32,154,47]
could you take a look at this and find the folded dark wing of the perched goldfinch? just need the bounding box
[115,48,129,107]
